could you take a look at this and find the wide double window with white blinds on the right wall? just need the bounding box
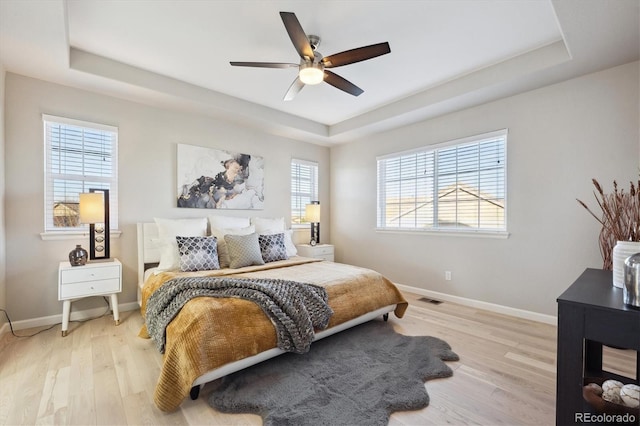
[377,130,507,233]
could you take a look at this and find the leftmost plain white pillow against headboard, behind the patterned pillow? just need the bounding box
[153,217,207,272]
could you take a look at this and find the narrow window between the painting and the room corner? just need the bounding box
[291,159,318,225]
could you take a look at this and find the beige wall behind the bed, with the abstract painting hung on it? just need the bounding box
[5,73,330,321]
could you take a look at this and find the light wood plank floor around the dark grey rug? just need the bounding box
[0,294,635,426]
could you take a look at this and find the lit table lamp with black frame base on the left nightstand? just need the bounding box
[80,188,110,261]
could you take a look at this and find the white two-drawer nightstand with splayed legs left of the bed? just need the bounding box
[58,259,122,337]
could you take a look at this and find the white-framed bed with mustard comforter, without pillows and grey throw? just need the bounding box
[137,223,407,411]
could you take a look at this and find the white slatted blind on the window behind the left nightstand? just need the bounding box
[42,115,118,232]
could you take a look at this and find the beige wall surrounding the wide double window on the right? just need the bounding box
[330,62,640,315]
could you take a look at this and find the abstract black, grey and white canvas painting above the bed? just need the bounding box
[177,144,264,210]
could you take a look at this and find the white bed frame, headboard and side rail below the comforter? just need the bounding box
[138,223,396,399]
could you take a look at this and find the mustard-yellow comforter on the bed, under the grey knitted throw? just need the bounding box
[140,257,407,411]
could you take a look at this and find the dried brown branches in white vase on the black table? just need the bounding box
[577,179,640,270]
